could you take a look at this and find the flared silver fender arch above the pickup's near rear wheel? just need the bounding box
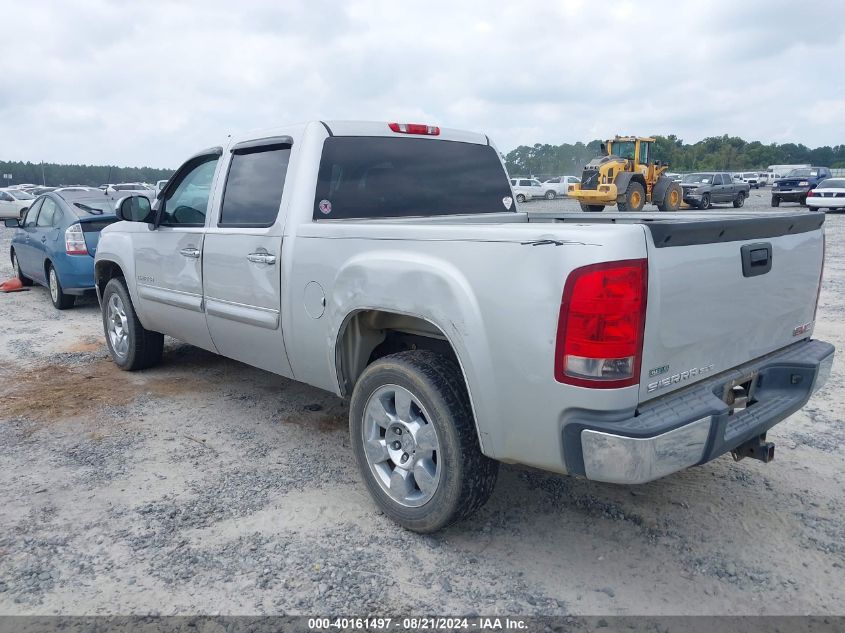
[326,250,494,457]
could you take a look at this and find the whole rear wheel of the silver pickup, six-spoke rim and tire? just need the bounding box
[349,350,499,533]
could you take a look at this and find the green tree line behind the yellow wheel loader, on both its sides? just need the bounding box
[505,134,845,176]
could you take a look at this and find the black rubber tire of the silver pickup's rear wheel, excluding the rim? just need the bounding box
[349,350,499,533]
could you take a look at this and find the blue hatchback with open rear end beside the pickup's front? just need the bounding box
[6,191,117,310]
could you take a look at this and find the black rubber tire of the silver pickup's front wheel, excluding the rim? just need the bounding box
[102,277,164,371]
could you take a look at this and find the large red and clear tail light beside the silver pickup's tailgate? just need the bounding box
[555,259,648,389]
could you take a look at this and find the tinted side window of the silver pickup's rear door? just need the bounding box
[218,145,290,227]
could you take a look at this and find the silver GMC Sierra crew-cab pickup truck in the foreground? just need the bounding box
[95,121,834,532]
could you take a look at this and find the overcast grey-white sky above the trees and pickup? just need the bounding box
[0,0,845,167]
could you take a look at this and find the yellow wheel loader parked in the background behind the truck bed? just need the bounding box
[568,136,683,212]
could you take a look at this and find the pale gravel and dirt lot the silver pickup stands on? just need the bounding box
[0,195,845,614]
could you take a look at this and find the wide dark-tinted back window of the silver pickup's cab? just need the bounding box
[313,136,521,220]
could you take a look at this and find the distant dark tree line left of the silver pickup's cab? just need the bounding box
[0,161,173,187]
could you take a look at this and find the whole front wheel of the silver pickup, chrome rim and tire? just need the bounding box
[102,277,164,371]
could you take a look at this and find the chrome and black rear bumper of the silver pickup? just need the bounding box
[563,340,834,484]
